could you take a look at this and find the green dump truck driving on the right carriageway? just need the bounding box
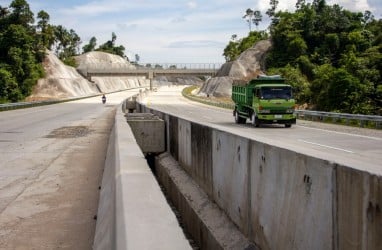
[232,75,296,128]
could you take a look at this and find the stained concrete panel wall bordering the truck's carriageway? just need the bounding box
[138,102,382,250]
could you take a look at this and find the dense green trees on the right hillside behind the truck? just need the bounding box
[223,0,382,115]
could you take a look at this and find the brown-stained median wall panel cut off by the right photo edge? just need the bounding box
[336,166,382,250]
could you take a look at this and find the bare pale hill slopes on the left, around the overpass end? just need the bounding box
[27,51,147,101]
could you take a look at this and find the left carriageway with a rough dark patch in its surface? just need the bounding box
[0,90,137,249]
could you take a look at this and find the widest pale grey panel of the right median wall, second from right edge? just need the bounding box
[249,141,334,249]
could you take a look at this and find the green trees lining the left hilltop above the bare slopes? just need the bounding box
[0,0,125,103]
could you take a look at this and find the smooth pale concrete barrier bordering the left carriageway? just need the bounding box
[93,104,191,250]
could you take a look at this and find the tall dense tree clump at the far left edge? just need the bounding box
[0,0,44,102]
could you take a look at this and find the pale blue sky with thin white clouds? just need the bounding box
[0,0,382,64]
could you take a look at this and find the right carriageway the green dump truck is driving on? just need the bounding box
[144,86,382,174]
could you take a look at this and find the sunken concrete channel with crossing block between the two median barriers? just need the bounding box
[125,109,257,250]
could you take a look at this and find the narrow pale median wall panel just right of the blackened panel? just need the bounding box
[212,130,249,234]
